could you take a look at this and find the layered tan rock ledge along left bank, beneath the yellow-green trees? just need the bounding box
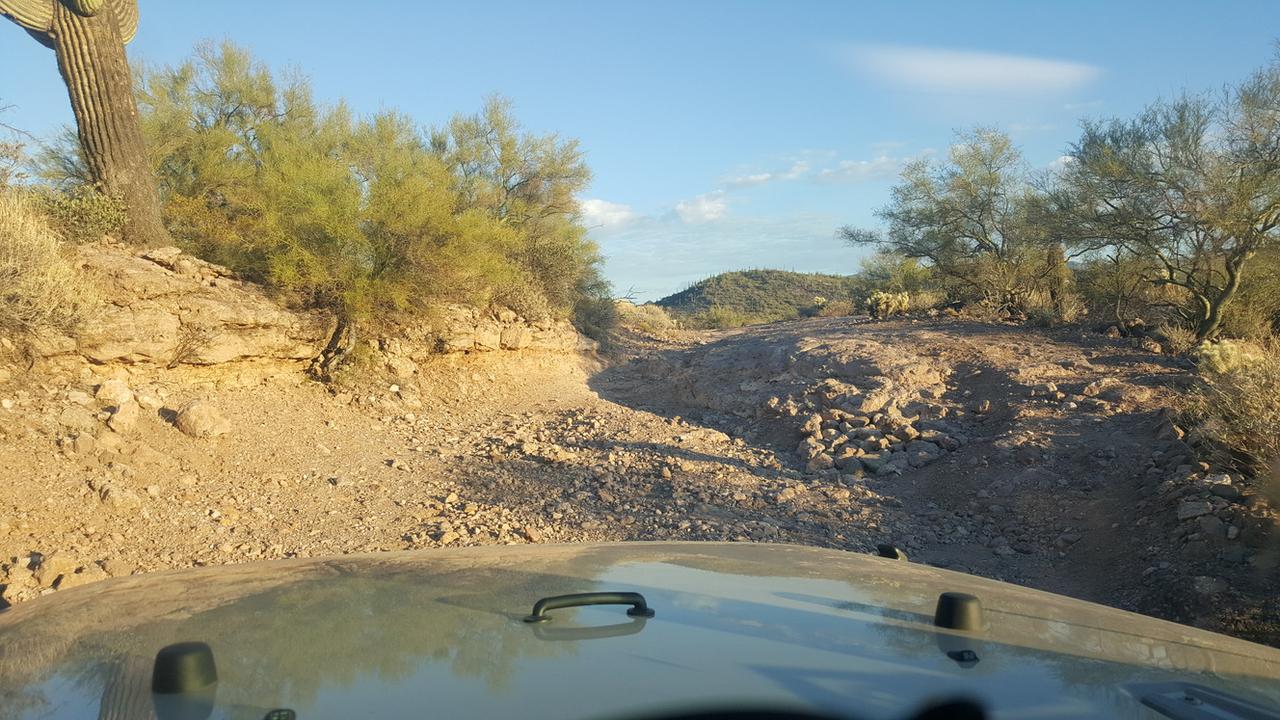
[21,242,595,368]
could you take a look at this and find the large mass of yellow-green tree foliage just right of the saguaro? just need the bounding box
[120,44,607,330]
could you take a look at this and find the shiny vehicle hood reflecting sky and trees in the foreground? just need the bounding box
[0,543,1280,720]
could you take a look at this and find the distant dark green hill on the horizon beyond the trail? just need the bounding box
[657,270,855,322]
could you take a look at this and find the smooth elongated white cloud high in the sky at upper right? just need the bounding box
[847,45,1102,95]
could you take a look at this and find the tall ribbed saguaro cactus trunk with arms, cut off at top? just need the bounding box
[0,0,169,245]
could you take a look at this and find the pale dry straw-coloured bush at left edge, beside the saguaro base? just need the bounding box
[0,190,95,334]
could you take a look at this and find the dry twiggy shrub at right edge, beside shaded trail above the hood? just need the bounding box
[1184,342,1280,473]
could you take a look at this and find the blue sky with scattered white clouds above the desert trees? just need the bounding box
[0,0,1280,300]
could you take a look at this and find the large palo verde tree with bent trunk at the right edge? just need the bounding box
[1055,57,1280,341]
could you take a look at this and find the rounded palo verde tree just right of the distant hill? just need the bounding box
[838,128,1064,311]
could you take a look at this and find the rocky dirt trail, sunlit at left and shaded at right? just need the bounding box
[0,293,1280,643]
